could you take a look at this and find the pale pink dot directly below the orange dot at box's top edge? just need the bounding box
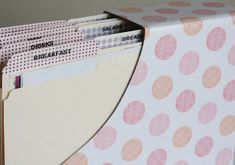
[179,51,199,75]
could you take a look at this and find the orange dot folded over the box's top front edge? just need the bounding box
[181,17,203,36]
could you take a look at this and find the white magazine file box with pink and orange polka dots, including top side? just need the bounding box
[64,1,235,165]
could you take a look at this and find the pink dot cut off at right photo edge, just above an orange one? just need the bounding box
[223,80,235,102]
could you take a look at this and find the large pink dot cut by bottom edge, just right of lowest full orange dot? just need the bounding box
[147,149,167,165]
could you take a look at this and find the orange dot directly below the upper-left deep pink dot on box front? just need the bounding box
[152,76,173,100]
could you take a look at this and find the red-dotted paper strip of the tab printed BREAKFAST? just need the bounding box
[2,40,98,74]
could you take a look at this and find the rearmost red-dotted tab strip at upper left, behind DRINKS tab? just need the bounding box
[0,20,67,34]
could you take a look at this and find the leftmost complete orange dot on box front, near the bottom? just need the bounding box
[122,139,143,161]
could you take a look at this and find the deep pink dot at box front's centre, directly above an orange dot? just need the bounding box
[176,90,196,112]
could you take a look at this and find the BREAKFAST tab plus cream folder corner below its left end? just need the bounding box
[2,40,97,99]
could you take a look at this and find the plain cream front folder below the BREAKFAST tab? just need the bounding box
[4,45,140,165]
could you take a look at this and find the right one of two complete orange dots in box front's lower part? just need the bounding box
[173,127,192,148]
